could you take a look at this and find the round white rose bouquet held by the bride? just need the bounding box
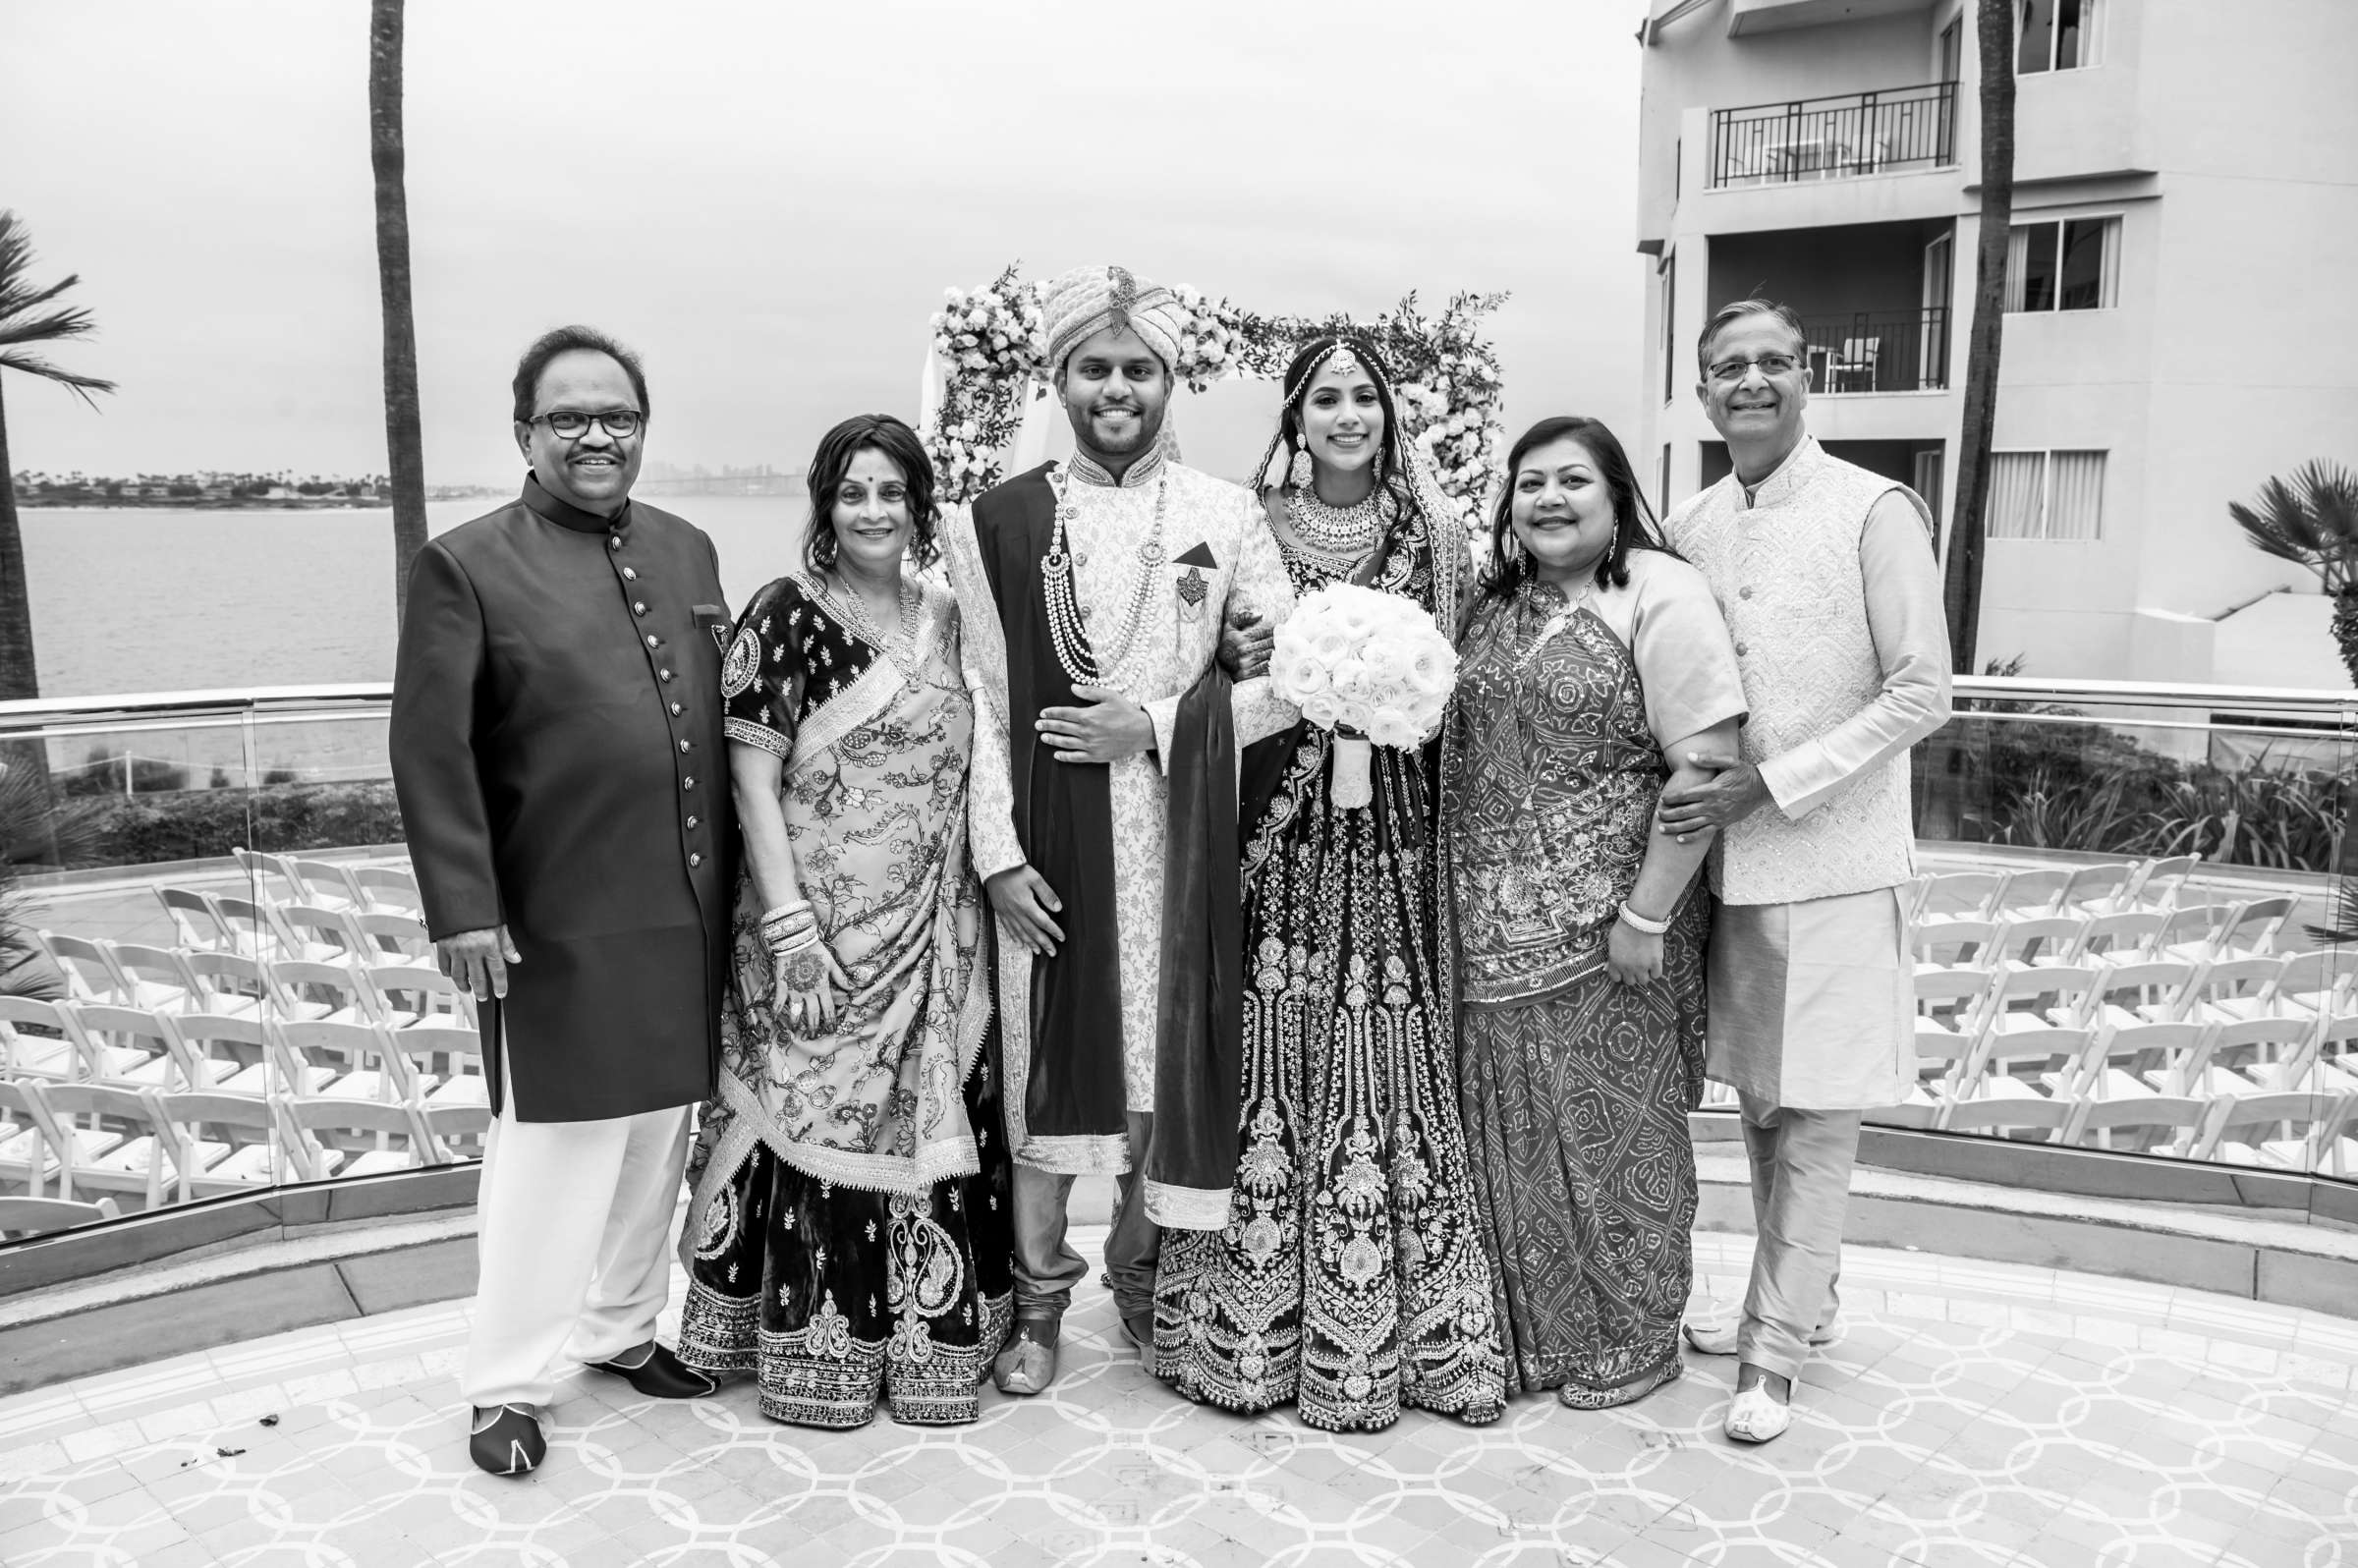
[1268,583,1457,807]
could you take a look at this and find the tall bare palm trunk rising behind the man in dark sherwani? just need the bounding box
[367,0,426,618]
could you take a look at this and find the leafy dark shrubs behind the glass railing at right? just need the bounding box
[1915,702,2351,872]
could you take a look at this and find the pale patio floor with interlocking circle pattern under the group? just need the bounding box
[0,1236,2358,1568]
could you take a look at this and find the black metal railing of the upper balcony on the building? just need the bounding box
[1705,83,1957,191]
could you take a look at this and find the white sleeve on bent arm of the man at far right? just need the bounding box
[1759,490,1947,818]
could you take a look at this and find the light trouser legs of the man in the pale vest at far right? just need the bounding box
[1735,1094,1863,1381]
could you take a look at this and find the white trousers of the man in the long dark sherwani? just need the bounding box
[460,1096,694,1405]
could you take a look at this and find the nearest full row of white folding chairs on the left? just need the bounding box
[0,1080,490,1207]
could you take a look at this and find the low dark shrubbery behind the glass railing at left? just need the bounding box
[76,778,401,866]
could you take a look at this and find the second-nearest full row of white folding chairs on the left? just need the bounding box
[0,990,485,1103]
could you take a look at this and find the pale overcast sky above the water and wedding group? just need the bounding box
[0,0,1644,483]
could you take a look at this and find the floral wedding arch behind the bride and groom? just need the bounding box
[920,264,1507,531]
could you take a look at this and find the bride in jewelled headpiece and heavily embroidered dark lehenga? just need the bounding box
[1155,335,1504,1431]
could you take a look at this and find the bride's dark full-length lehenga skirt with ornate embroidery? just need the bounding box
[1155,526,1504,1431]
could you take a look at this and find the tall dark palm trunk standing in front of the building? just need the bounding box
[1945,0,2014,674]
